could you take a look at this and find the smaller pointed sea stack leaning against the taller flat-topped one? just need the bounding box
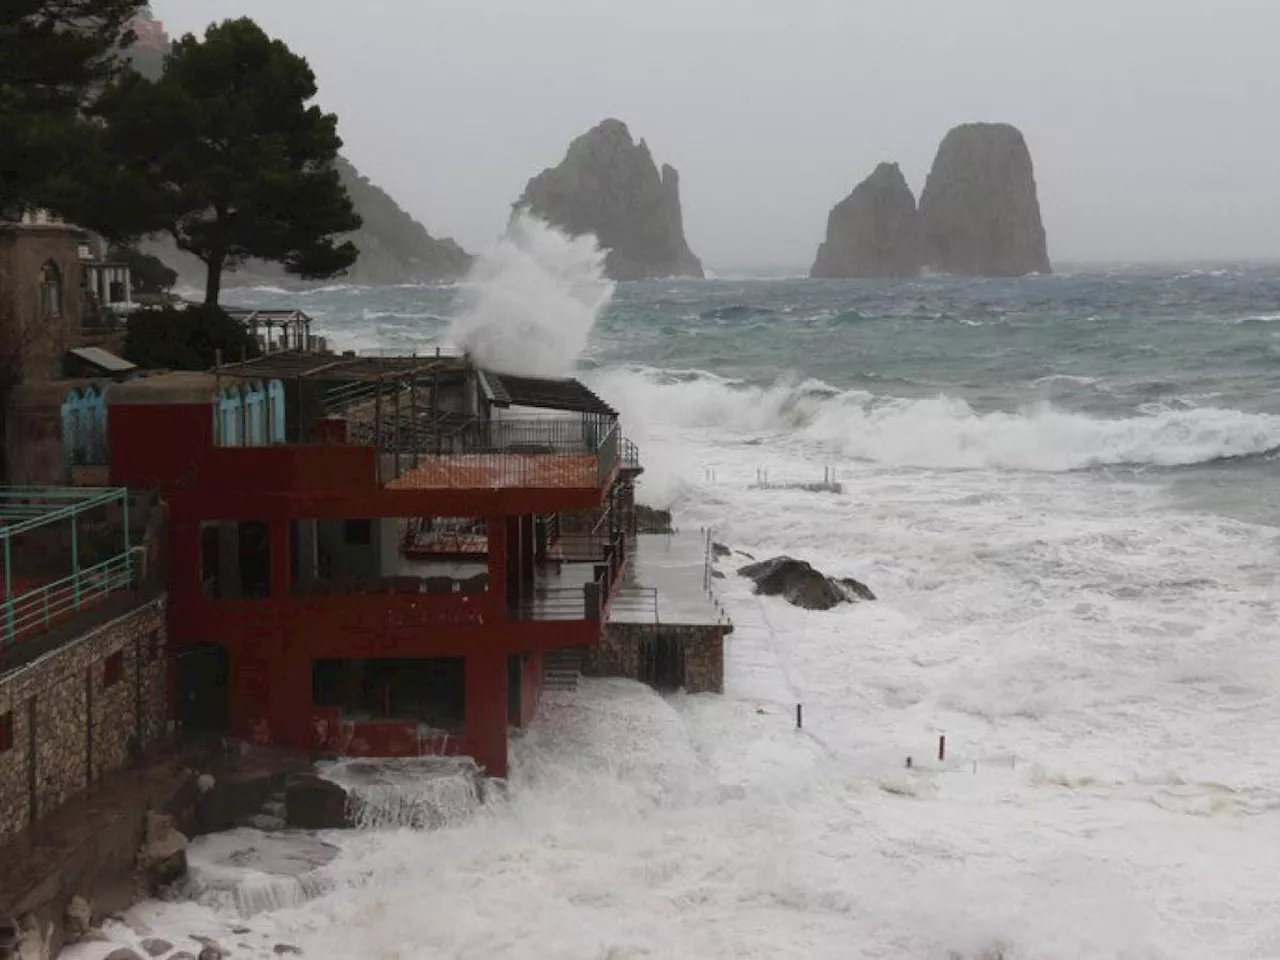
[809,164,920,278]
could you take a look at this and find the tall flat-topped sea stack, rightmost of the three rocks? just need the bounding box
[919,123,1051,276]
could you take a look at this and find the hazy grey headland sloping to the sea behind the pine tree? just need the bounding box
[142,159,474,287]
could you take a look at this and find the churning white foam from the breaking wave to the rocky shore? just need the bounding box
[72,272,1280,960]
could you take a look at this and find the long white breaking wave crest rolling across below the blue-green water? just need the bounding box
[594,370,1280,472]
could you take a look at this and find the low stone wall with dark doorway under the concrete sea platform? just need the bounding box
[582,623,733,694]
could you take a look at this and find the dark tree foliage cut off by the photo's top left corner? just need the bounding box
[0,0,145,219]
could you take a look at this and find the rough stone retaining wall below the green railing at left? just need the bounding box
[0,598,169,842]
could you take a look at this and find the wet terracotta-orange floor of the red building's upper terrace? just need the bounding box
[388,453,599,490]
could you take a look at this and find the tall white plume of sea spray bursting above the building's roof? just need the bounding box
[448,214,614,376]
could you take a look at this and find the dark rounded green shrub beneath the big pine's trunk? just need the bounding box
[124,306,261,370]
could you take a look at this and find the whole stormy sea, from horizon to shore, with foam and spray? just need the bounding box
[67,225,1280,960]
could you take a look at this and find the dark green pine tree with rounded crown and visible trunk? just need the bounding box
[96,19,361,306]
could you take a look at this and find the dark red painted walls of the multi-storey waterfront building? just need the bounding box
[110,403,604,777]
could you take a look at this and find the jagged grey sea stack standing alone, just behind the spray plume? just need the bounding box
[515,119,703,280]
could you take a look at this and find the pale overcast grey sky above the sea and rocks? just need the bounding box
[154,0,1280,269]
